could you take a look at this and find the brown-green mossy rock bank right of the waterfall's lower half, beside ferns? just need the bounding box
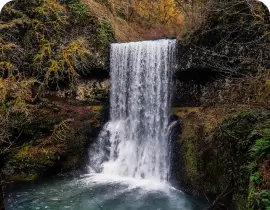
[177,107,269,209]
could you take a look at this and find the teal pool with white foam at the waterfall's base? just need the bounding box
[5,175,205,210]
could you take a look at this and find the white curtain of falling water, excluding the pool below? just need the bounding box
[89,40,177,181]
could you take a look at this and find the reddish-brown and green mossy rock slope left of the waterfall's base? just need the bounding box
[1,97,105,181]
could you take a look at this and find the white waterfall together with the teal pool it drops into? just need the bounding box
[3,40,203,210]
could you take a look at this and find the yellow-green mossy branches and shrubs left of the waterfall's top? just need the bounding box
[0,0,114,153]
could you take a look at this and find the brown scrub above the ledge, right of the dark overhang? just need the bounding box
[201,67,270,107]
